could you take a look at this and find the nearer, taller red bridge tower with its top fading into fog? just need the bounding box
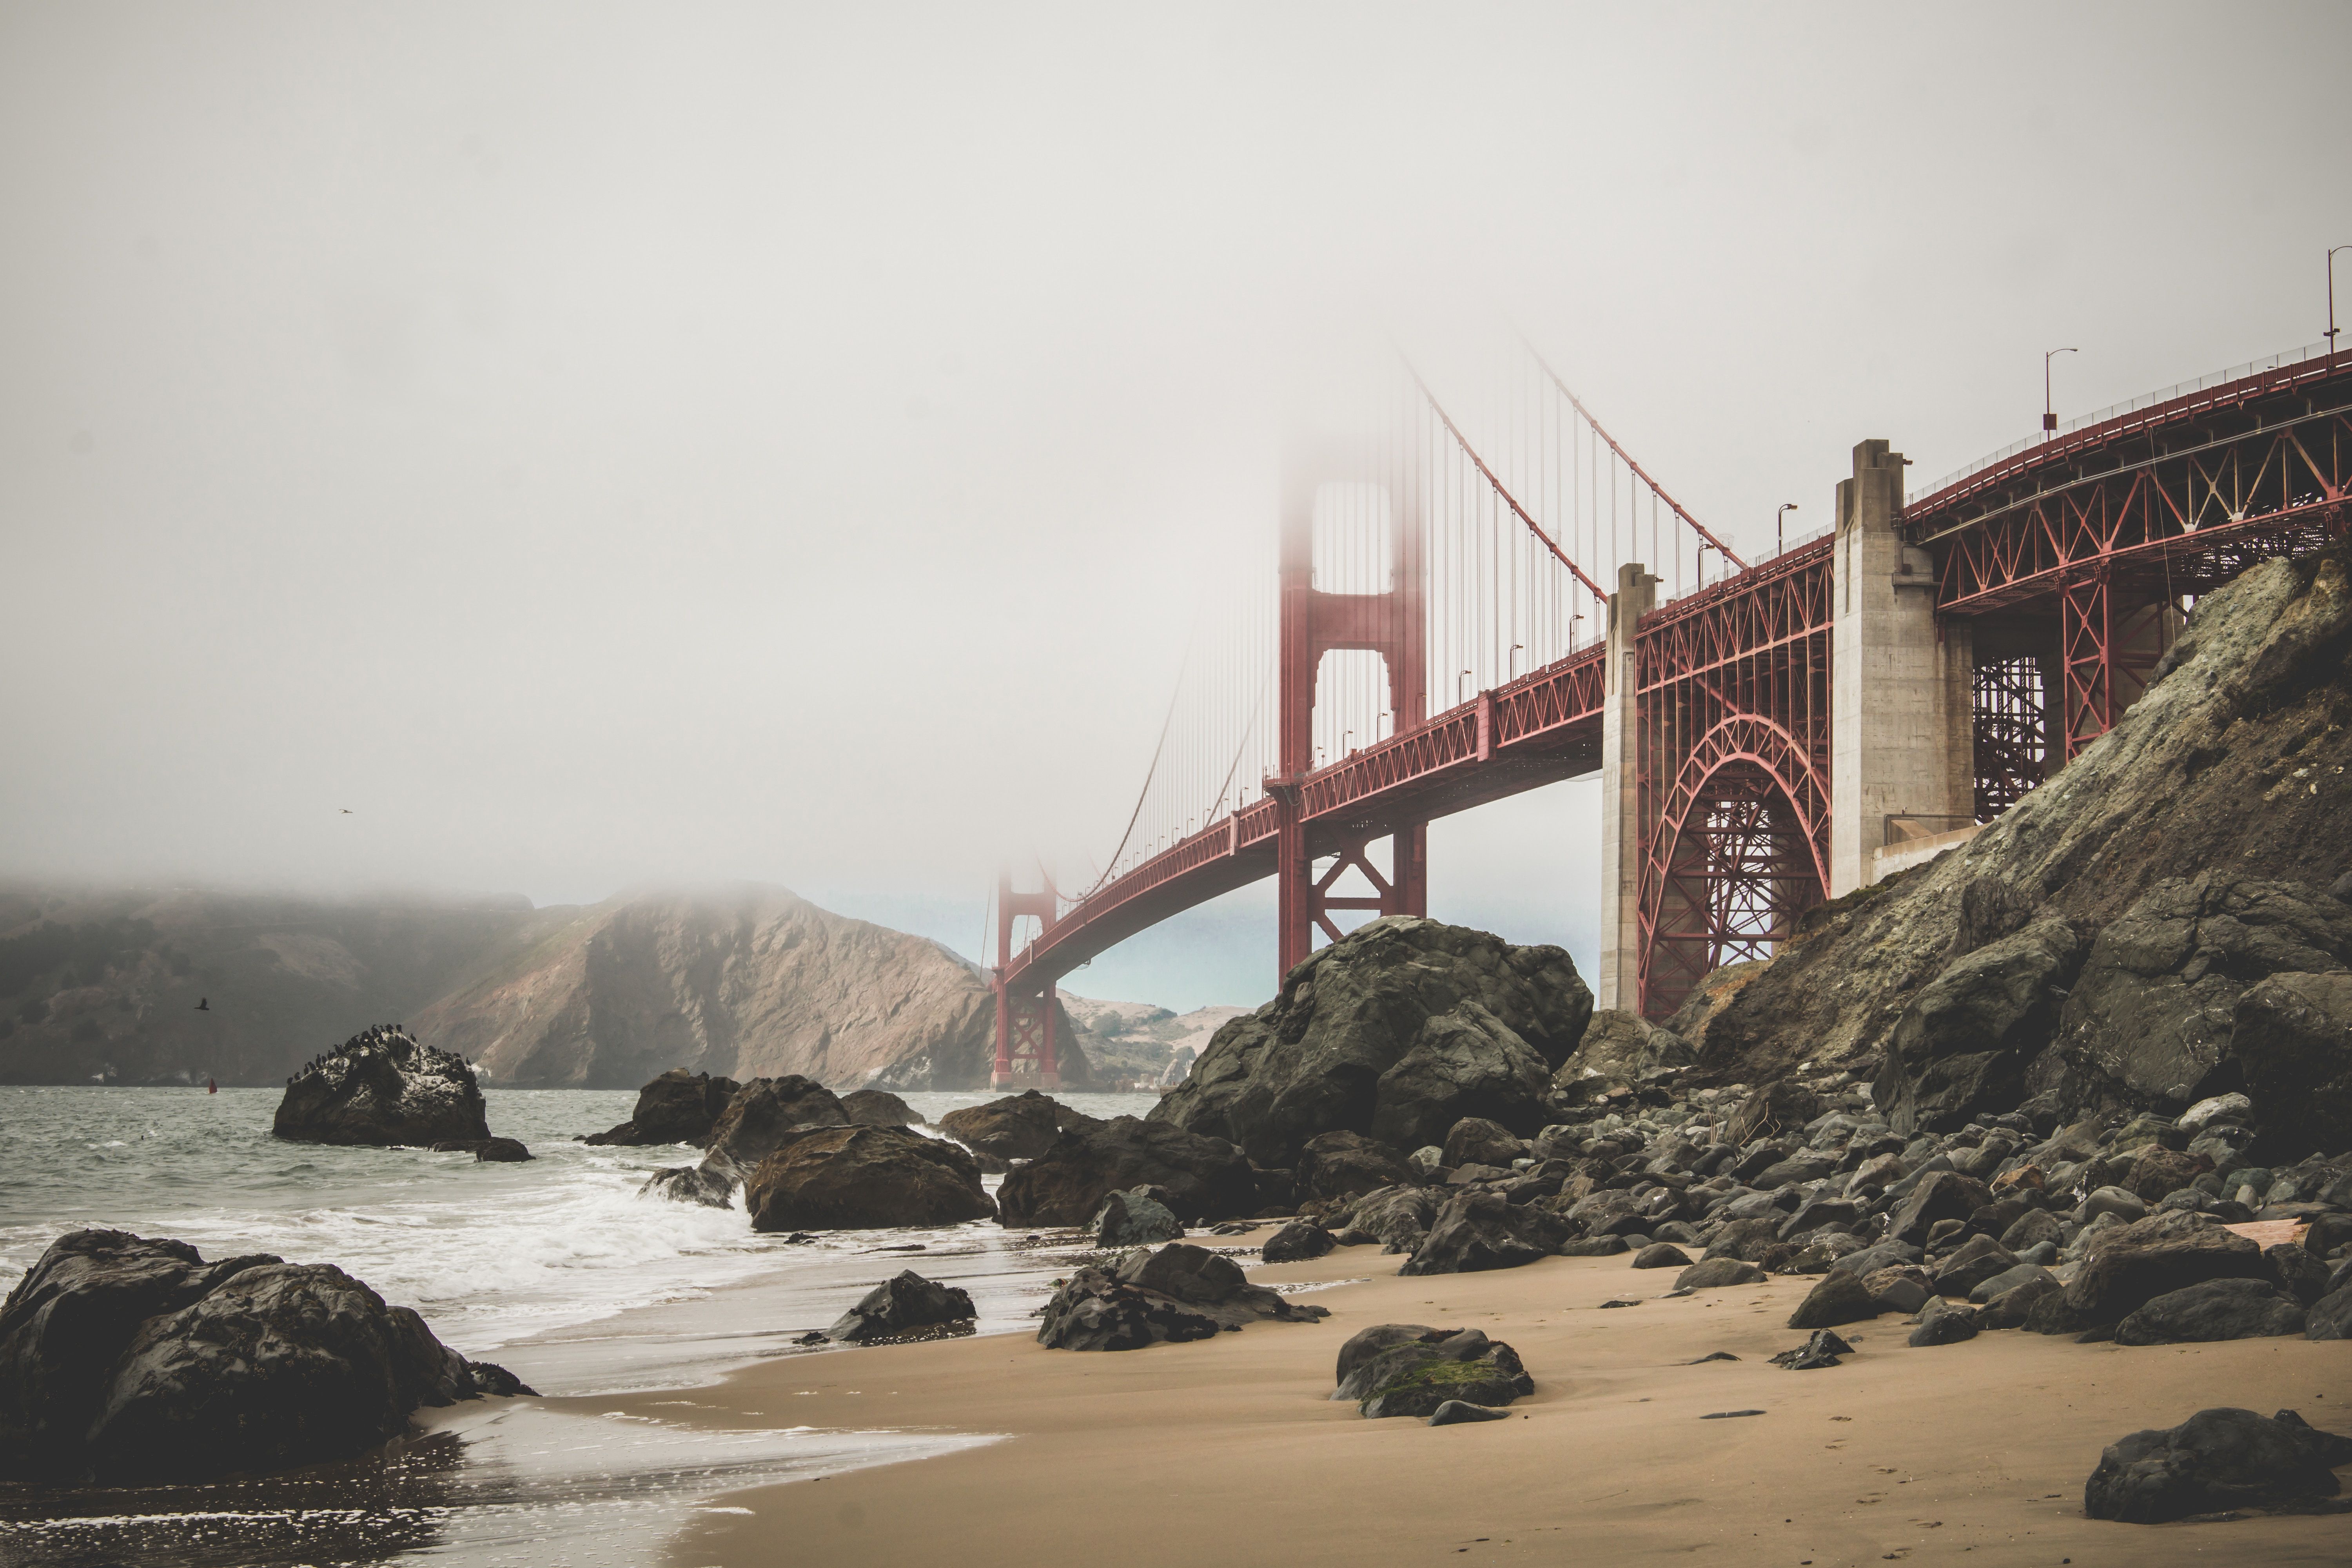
[1265,444,1430,976]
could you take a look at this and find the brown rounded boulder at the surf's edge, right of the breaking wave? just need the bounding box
[743,1126,997,1229]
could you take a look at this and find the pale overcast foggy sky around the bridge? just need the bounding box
[0,0,2352,1006]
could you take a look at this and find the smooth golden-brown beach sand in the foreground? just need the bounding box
[644,1232,2352,1568]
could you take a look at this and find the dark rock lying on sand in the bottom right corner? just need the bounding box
[2082,1408,2352,1523]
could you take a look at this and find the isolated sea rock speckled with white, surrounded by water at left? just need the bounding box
[270,1025,489,1147]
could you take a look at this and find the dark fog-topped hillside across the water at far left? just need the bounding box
[0,884,572,1084]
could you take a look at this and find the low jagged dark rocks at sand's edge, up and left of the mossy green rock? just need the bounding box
[1037,1241,1329,1349]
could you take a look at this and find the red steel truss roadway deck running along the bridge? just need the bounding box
[1000,353,2352,992]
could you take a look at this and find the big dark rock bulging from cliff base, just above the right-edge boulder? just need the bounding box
[2058,872,2352,1114]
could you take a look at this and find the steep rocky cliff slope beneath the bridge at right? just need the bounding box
[1668,552,2352,1129]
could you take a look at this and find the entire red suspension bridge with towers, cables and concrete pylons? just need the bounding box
[993,346,2352,1086]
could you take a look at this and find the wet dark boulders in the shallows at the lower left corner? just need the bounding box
[0,1229,529,1486]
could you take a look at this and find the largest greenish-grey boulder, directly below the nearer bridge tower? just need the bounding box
[1152,917,1592,1169]
